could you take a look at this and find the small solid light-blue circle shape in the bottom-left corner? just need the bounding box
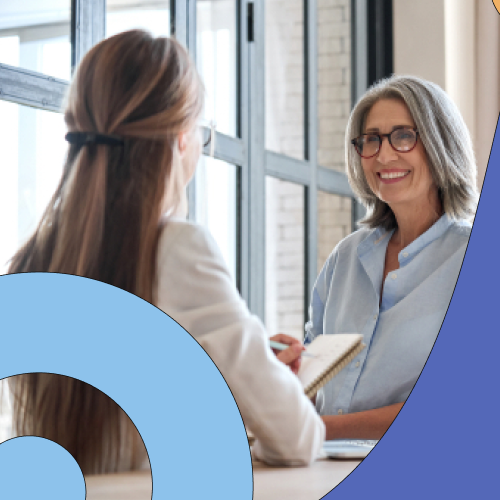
[0,436,85,500]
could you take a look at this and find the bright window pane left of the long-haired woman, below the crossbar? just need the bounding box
[0,101,66,272]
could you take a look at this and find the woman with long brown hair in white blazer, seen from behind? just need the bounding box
[9,31,325,470]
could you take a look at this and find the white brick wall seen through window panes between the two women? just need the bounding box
[266,0,351,339]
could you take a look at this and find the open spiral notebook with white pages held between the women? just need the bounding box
[297,333,366,398]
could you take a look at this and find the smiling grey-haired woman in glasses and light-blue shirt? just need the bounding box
[306,77,477,439]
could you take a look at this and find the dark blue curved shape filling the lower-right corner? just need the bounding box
[324,115,500,500]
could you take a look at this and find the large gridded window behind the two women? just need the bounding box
[0,0,387,338]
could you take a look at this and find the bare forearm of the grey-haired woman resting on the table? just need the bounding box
[321,403,404,440]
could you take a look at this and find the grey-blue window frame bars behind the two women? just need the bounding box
[0,0,392,328]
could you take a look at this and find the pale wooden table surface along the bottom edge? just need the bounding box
[85,459,359,500]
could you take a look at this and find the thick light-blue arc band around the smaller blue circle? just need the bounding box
[0,273,253,500]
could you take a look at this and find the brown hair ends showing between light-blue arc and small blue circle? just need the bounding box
[7,373,149,474]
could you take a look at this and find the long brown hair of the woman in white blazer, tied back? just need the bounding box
[9,30,204,472]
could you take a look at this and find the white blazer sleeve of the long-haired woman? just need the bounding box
[156,223,325,465]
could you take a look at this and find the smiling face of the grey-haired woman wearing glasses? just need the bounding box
[361,99,437,213]
